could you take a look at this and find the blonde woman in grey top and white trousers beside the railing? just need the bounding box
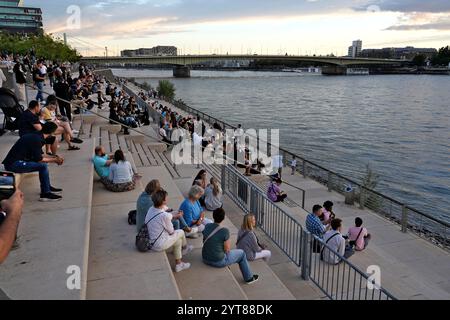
[236,213,272,262]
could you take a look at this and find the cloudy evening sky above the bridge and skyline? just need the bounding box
[24,0,450,56]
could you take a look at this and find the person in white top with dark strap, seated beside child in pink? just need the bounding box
[320,219,355,264]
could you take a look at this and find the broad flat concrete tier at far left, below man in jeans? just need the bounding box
[0,139,94,300]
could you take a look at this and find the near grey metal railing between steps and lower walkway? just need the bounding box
[222,165,396,300]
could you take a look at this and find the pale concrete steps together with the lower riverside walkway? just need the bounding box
[0,75,450,301]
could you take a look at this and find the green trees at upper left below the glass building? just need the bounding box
[0,33,81,62]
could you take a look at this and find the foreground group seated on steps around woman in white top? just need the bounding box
[136,170,264,283]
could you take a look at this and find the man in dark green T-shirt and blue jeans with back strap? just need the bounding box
[202,208,259,284]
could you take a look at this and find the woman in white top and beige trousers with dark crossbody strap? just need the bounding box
[145,189,193,272]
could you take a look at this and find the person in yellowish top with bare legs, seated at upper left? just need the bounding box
[41,95,83,150]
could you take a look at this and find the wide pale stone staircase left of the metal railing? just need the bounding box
[0,105,323,300]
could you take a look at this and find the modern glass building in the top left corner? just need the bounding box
[0,0,42,34]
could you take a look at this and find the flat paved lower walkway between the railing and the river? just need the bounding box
[122,80,450,299]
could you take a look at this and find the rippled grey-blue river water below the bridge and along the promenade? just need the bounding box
[114,69,450,221]
